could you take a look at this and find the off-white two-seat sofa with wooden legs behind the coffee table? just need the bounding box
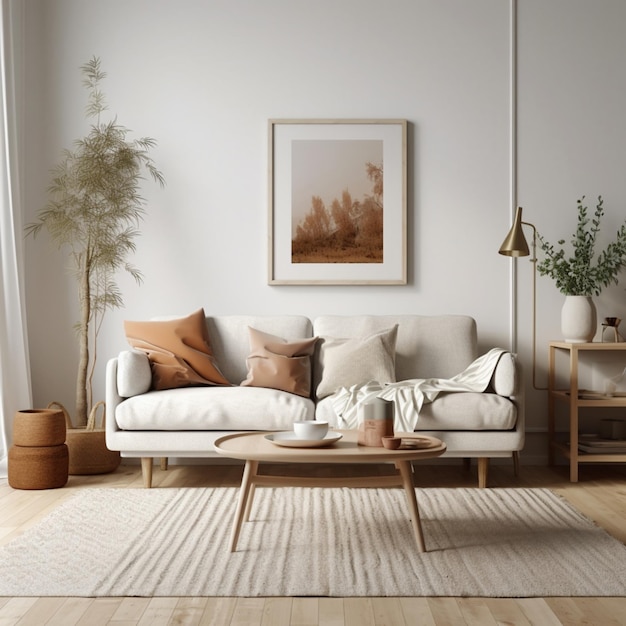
[106,315,524,487]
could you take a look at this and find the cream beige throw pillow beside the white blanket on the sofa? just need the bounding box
[315,324,398,399]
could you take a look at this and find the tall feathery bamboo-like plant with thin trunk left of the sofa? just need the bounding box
[26,57,165,427]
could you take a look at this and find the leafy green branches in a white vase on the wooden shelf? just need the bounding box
[537,196,626,342]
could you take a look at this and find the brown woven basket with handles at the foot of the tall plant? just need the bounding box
[48,402,122,475]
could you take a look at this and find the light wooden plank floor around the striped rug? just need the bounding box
[0,463,626,626]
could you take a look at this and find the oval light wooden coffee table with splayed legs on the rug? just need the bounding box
[215,430,446,552]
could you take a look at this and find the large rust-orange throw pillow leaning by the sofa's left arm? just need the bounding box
[124,309,230,390]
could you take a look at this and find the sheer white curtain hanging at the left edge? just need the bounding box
[0,0,32,478]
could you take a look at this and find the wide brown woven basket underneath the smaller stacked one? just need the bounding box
[9,443,69,489]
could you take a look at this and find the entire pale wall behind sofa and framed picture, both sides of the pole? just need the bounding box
[18,0,626,454]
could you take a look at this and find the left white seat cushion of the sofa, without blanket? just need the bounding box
[115,387,315,431]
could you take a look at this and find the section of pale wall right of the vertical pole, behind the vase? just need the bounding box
[518,0,626,448]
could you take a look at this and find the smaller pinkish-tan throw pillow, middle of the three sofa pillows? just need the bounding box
[241,327,317,398]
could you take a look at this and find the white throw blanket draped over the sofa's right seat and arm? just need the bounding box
[331,348,506,433]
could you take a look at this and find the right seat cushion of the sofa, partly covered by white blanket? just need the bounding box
[315,392,517,431]
